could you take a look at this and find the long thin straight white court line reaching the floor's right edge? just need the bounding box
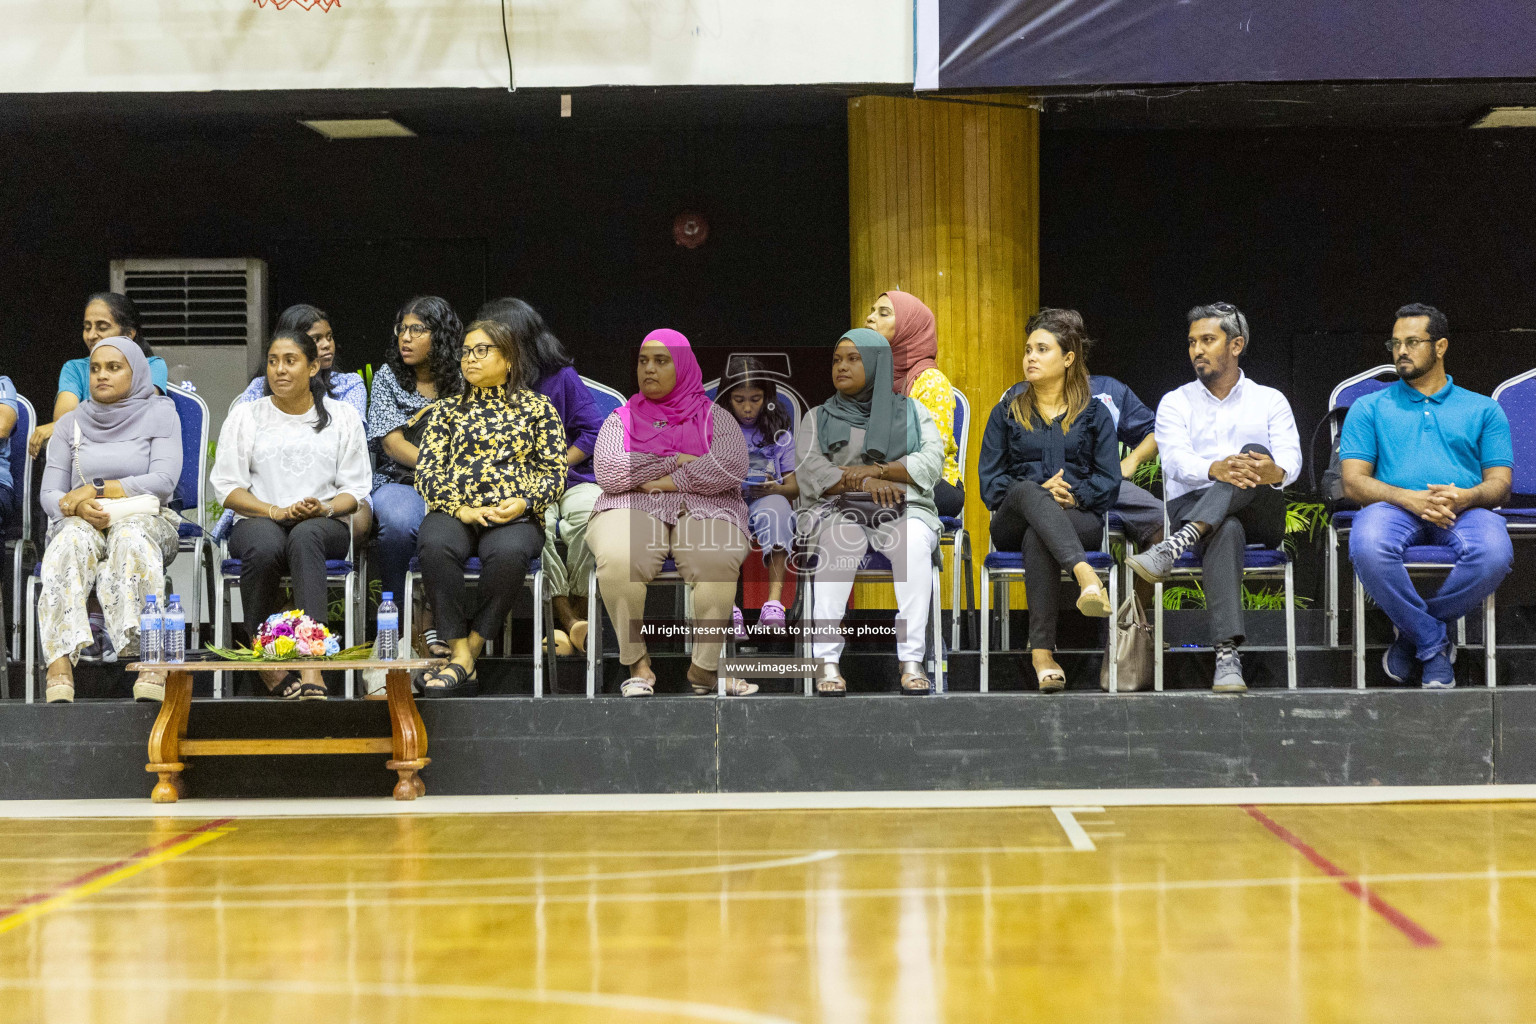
[51,869,1536,917]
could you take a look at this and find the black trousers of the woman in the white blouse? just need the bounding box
[229,519,349,636]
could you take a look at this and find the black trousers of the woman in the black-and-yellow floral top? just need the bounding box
[416,511,544,640]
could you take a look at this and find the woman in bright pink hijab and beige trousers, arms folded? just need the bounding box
[587,330,757,697]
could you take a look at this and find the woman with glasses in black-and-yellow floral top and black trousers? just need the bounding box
[416,319,565,697]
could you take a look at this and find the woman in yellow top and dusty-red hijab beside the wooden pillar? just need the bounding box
[865,289,965,519]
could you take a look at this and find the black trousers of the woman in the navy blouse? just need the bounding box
[992,481,1104,651]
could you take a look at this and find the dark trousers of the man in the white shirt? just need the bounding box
[1167,445,1286,643]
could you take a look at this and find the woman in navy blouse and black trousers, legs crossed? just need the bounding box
[980,309,1120,692]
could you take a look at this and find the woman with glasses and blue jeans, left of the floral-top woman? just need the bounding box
[369,295,464,641]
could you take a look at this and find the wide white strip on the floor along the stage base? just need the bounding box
[9,792,1536,822]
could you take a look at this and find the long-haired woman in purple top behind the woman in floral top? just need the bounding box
[476,298,602,654]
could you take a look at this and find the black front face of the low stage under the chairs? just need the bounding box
[9,686,1536,800]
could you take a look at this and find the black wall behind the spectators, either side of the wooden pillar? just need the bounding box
[0,115,1536,491]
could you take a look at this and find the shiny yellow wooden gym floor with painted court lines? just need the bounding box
[0,803,1536,1024]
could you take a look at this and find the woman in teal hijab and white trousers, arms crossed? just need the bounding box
[796,327,945,695]
